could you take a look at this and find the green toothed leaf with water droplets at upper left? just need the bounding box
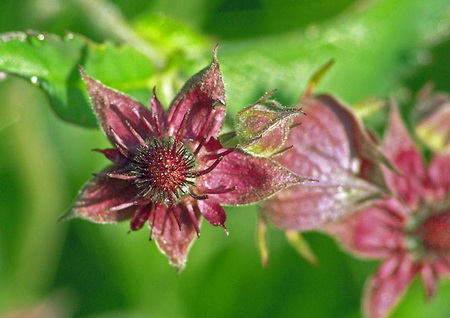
[0,32,155,127]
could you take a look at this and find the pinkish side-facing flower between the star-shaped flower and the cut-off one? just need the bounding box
[263,95,385,231]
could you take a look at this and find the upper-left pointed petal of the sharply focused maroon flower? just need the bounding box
[80,68,155,149]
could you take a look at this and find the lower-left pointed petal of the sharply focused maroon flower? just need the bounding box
[62,168,138,223]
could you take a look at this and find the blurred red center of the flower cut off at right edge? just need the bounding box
[419,211,450,252]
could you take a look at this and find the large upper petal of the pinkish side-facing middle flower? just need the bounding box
[277,95,385,188]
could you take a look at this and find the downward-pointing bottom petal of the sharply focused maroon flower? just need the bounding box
[150,205,200,272]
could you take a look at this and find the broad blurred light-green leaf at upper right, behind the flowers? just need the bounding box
[219,0,450,113]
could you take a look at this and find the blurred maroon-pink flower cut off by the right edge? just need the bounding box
[328,107,450,317]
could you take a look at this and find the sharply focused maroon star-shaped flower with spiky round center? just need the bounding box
[63,49,305,271]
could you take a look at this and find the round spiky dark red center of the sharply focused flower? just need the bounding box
[132,137,196,204]
